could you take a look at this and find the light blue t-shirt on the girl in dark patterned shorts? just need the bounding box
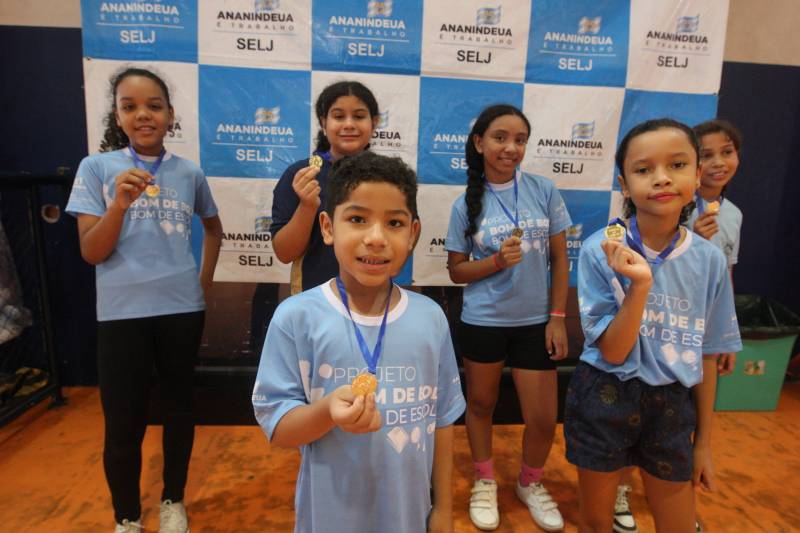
[578,230,742,387]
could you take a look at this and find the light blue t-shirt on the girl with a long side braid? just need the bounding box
[444,172,572,326]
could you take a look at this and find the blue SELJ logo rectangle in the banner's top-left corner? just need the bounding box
[81,0,197,62]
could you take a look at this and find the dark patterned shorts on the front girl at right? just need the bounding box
[564,362,697,481]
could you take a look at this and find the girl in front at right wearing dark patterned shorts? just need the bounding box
[564,119,741,533]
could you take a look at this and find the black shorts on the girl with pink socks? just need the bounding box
[458,321,556,370]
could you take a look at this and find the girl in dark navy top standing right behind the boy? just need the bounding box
[270,81,380,294]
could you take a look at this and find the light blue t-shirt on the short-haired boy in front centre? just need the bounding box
[253,282,466,533]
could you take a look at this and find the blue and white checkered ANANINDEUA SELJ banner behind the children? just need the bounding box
[81,0,728,285]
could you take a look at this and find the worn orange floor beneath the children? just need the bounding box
[0,383,800,533]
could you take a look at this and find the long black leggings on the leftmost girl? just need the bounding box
[97,311,205,523]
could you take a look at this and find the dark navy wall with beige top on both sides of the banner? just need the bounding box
[0,0,800,384]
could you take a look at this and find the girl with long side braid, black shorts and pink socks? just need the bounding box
[445,105,571,531]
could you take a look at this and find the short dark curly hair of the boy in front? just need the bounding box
[325,150,419,219]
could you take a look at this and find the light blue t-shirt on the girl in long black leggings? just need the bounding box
[67,148,217,322]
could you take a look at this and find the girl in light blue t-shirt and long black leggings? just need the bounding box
[67,68,222,533]
